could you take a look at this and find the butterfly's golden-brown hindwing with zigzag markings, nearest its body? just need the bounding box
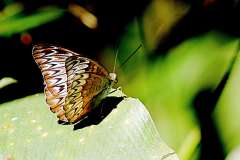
[64,56,110,123]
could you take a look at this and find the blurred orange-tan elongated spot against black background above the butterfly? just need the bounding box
[68,4,98,29]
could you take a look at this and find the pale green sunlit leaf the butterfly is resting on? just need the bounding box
[0,91,178,160]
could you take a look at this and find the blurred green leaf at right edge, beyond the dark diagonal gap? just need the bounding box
[213,40,240,152]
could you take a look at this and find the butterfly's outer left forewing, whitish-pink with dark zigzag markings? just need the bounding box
[32,44,79,121]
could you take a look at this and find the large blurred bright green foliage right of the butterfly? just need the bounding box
[114,19,239,159]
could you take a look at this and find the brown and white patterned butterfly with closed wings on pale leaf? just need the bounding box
[32,44,117,124]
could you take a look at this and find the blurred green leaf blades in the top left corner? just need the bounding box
[0,4,64,37]
